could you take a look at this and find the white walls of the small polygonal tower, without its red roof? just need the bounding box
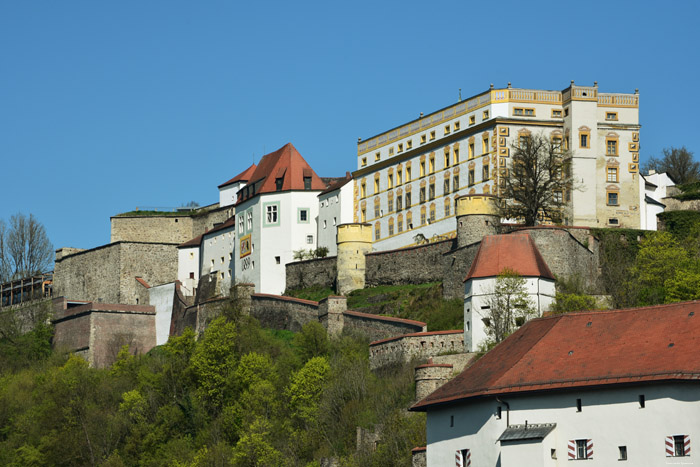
[464,277,556,352]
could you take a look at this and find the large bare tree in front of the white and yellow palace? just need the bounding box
[501,135,574,225]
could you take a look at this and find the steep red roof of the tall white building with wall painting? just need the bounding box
[236,143,326,203]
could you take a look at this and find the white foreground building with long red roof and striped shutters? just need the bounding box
[411,302,700,467]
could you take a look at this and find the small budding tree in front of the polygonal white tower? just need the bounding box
[485,268,537,344]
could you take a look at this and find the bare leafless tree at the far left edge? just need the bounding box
[0,213,53,282]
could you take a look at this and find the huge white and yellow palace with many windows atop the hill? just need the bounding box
[353,81,641,250]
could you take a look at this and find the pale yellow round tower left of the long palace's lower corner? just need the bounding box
[337,223,372,295]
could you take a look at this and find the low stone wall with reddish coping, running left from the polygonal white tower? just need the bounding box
[369,329,464,369]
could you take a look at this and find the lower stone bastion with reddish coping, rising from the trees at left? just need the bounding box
[53,300,156,368]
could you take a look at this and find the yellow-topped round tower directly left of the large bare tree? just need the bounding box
[456,194,501,247]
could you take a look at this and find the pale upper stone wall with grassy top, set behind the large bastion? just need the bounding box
[110,216,199,245]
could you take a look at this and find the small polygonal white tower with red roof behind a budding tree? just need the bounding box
[464,233,556,352]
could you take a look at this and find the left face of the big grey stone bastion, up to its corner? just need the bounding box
[53,243,121,303]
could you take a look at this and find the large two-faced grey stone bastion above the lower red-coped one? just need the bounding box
[53,242,177,304]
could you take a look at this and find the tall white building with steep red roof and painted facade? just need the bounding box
[234,143,326,294]
